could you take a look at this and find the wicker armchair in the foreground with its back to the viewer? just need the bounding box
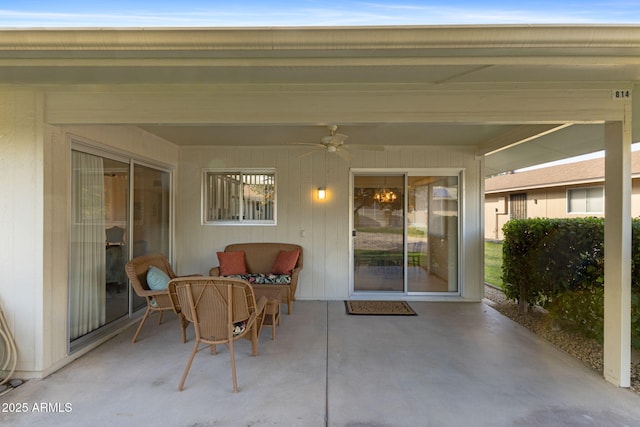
[169,277,267,393]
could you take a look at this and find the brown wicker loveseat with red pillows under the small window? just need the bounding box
[209,243,302,314]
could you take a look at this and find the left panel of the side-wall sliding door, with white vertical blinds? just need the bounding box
[69,150,129,341]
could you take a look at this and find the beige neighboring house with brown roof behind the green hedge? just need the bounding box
[484,151,640,240]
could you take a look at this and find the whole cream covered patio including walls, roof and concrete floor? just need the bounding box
[0,26,640,398]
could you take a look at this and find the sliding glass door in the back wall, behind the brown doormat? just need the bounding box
[352,171,459,294]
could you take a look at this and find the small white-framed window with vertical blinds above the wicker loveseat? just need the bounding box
[202,169,276,224]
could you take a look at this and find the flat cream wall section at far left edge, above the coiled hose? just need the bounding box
[0,91,46,370]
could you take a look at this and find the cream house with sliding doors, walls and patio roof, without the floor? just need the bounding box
[0,25,640,386]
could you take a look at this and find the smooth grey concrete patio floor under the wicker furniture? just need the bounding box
[0,301,640,427]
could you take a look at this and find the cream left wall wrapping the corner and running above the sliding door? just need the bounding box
[0,98,178,378]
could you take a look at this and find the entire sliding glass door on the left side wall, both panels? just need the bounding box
[69,149,170,350]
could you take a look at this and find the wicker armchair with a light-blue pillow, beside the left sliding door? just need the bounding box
[125,254,194,343]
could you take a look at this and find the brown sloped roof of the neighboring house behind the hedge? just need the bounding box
[485,151,640,194]
